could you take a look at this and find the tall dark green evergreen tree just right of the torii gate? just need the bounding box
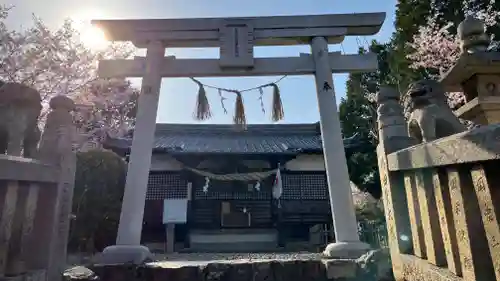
[339,0,430,199]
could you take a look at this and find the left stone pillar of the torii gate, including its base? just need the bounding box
[96,41,165,264]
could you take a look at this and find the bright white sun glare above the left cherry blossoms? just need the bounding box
[71,11,109,49]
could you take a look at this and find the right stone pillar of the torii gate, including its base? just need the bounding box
[311,37,370,258]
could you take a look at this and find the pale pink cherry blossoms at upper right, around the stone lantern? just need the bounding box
[407,0,500,108]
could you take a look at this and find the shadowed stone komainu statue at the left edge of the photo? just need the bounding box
[0,82,42,158]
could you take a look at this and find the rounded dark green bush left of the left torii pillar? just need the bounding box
[69,150,127,251]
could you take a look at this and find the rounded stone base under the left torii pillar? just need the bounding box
[92,245,153,265]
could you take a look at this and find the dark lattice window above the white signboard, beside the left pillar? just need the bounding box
[146,173,187,200]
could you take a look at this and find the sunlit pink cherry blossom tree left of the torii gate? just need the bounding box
[0,5,138,147]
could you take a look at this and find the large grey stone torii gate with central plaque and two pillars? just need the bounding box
[92,13,385,257]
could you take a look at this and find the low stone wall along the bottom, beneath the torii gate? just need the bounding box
[65,250,393,281]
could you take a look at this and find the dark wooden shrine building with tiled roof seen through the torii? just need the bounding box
[105,123,359,251]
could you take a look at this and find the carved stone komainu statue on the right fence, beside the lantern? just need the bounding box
[403,79,467,143]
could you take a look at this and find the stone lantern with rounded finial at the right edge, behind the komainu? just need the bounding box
[441,17,500,125]
